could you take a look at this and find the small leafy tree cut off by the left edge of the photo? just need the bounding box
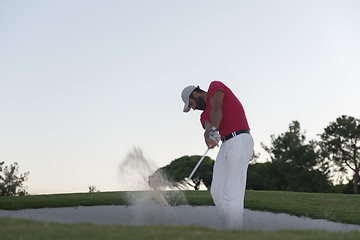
[0,162,29,196]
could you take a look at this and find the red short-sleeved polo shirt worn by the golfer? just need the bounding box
[200,81,250,137]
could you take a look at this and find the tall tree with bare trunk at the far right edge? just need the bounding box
[320,115,360,194]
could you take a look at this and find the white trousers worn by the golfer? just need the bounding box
[211,133,254,229]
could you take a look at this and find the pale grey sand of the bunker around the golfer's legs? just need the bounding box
[0,205,360,232]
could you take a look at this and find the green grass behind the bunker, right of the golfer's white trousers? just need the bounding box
[245,191,360,225]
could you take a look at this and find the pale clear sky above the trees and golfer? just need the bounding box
[0,0,360,194]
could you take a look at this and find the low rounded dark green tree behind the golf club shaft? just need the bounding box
[149,155,215,190]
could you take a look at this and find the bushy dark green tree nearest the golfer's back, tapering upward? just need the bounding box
[260,121,330,192]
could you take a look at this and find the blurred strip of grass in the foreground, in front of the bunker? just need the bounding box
[0,218,360,240]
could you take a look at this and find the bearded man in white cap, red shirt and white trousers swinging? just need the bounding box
[181,81,254,229]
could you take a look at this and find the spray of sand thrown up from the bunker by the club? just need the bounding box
[119,147,186,225]
